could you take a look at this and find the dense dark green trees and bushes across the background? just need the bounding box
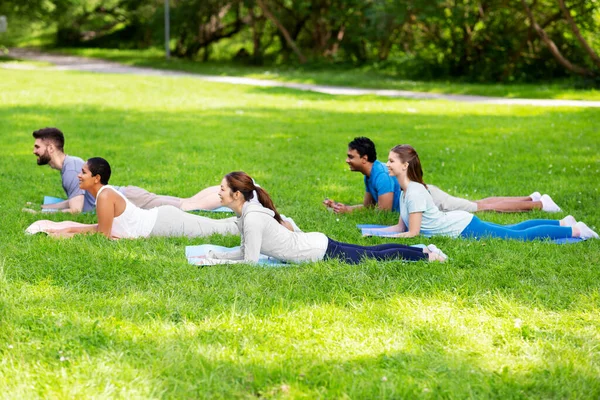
[5,0,600,81]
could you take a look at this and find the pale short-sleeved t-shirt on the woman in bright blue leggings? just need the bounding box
[400,181,473,237]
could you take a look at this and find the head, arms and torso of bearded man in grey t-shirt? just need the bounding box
[33,128,96,213]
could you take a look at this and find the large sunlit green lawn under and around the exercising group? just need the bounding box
[0,67,600,399]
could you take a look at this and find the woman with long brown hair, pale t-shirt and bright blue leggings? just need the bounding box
[368,145,598,240]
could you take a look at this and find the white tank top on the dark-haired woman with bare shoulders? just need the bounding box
[96,185,158,239]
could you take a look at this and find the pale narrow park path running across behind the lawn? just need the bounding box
[0,49,600,107]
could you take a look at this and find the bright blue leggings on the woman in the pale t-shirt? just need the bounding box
[460,216,573,240]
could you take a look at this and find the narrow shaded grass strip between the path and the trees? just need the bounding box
[14,48,600,100]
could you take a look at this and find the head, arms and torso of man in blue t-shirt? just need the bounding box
[323,137,400,213]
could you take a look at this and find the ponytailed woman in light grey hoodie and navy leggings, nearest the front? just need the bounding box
[206,172,446,264]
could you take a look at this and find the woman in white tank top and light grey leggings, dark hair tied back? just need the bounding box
[28,157,238,239]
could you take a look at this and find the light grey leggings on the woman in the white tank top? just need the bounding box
[150,206,240,237]
